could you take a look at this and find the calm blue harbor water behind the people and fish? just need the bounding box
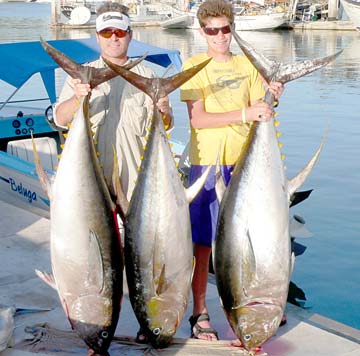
[0,2,360,329]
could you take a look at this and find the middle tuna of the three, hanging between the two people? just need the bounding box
[102,56,208,347]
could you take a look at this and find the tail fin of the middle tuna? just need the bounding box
[103,58,211,101]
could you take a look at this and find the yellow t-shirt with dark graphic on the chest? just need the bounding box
[180,53,265,165]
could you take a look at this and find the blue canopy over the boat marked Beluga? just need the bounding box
[0,37,181,103]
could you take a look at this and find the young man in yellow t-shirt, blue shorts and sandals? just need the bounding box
[181,0,283,341]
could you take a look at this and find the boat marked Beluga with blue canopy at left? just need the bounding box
[0,37,181,218]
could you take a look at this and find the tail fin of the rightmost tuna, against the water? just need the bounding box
[232,29,342,86]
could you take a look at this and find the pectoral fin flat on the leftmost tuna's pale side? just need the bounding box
[87,230,104,291]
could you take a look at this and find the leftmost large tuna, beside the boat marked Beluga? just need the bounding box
[32,42,145,355]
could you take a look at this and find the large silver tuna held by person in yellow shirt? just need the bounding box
[213,31,337,350]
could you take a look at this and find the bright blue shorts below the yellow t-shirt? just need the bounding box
[189,165,235,247]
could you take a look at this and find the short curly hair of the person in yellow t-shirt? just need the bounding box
[197,0,234,27]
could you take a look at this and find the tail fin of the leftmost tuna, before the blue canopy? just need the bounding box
[40,38,146,88]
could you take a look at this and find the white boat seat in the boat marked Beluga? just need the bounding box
[6,137,58,171]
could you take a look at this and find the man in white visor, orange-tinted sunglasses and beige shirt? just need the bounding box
[54,2,173,200]
